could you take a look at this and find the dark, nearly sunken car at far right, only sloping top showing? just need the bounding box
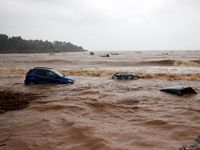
[160,86,197,96]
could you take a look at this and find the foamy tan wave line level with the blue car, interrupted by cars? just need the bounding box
[0,68,200,80]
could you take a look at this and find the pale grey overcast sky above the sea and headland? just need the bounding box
[0,0,200,50]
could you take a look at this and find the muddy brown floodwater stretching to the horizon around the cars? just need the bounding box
[0,51,200,150]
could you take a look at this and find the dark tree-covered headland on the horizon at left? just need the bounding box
[0,34,86,53]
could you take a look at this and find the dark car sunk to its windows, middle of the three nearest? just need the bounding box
[112,73,140,80]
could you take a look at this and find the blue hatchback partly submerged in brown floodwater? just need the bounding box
[24,67,74,85]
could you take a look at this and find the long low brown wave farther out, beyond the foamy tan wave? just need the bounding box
[17,59,200,67]
